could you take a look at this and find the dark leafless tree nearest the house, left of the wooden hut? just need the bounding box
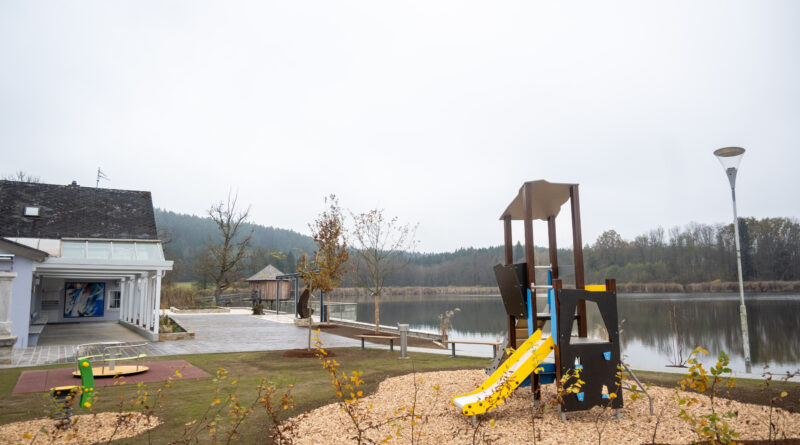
[199,192,253,304]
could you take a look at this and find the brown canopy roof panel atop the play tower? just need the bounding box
[500,179,578,221]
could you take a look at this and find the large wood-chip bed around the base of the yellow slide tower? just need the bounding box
[295,370,800,444]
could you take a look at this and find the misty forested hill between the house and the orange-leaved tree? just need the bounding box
[155,209,314,281]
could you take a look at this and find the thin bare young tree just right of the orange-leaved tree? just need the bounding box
[350,209,418,332]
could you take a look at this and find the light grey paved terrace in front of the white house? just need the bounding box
[2,313,361,368]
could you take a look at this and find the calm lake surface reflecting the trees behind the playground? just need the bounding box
[340,294,800,373]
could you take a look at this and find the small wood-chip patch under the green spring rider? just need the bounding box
[0,413,161,445]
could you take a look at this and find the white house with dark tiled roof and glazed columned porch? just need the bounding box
[0,180,172,348]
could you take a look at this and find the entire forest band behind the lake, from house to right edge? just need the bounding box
[156,210,800,286]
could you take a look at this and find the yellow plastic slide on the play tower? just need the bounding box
[450,330,553,416]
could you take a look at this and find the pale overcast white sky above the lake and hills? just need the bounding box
[0,0,800,252]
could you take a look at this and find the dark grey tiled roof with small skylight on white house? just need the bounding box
[0,180,158,239]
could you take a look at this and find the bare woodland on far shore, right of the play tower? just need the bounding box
[584,218,800,284]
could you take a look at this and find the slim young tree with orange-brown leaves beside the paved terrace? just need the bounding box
[297,195,350,351]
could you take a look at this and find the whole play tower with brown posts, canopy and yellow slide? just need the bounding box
[451,180,653,420]
